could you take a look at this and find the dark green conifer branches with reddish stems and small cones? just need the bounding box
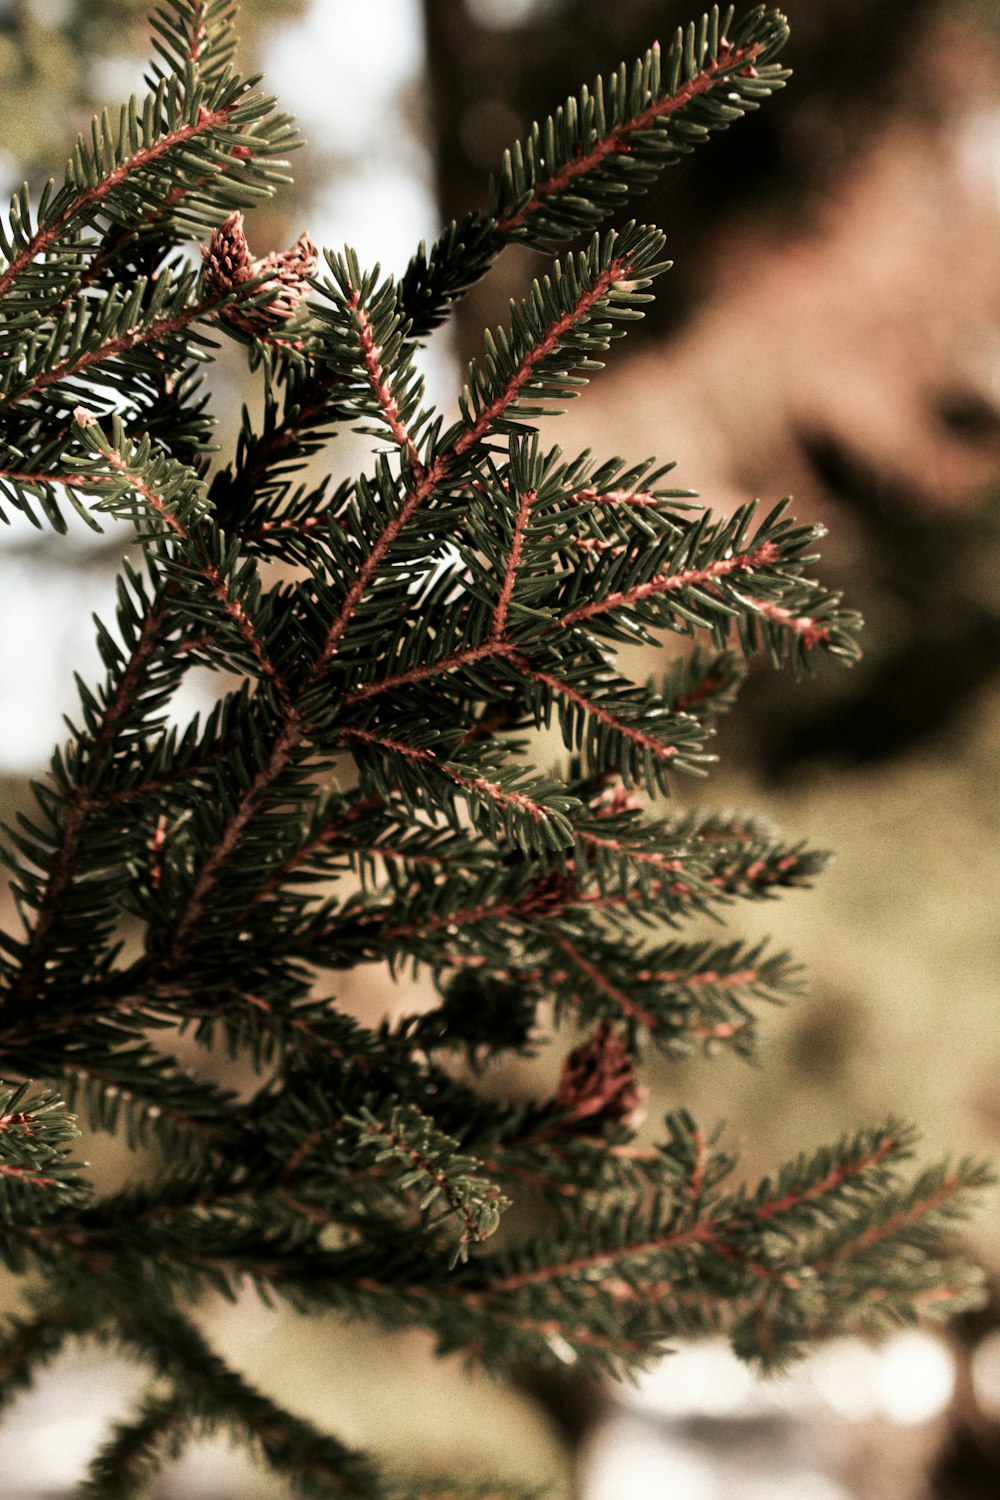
[0,0,985,1500]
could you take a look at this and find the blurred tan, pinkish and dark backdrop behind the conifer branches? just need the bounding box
[0,0,1000,1500]
